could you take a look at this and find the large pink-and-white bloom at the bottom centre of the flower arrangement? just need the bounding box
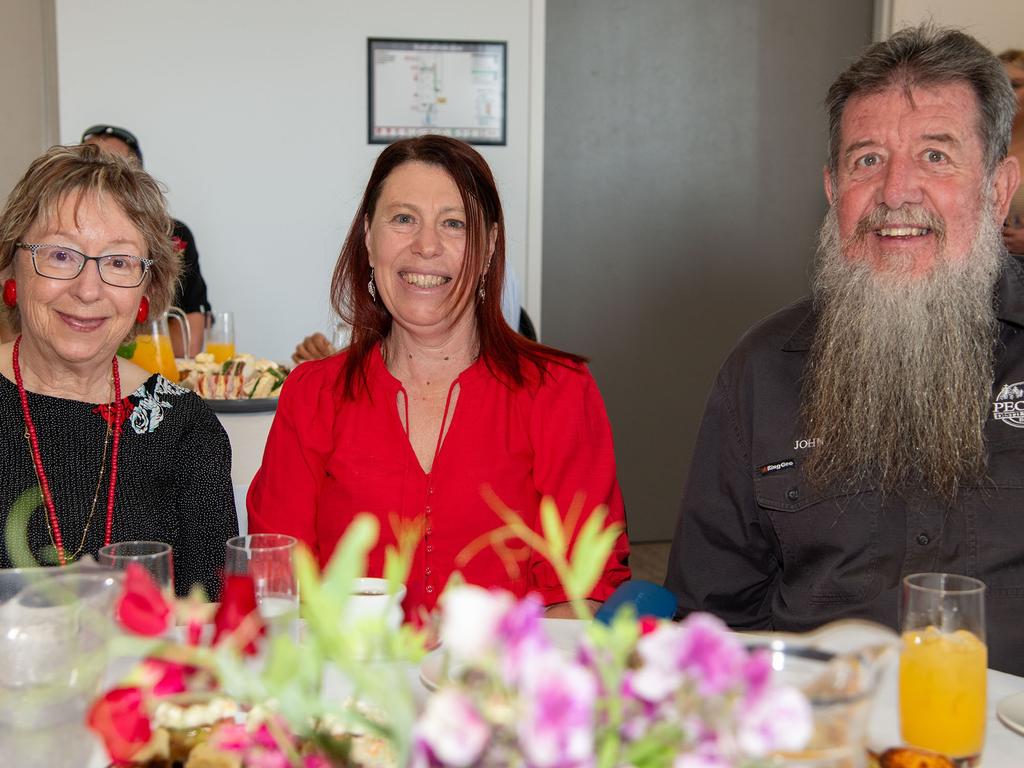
[518,651,597,768]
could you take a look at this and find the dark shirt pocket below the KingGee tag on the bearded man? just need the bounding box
[754,473,880,604]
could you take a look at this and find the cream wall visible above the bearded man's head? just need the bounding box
[878,0,1024,53]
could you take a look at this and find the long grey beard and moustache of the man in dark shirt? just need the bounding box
[802,198,1006,501]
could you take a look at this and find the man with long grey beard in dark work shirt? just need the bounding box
[666,26,1024,675]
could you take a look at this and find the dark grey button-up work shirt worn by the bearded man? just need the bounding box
[666,259,1024,675]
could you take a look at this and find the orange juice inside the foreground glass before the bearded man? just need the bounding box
[899,627,988,758]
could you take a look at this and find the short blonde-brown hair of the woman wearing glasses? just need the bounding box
[0,144,181,327]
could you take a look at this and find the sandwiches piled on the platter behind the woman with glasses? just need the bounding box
[178,352,288,400]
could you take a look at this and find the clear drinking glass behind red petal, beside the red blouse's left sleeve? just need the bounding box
[224,534,299,637]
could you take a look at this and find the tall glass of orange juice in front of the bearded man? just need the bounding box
[899,573,988,765]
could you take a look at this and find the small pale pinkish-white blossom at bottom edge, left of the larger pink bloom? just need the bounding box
[416,688,490,767]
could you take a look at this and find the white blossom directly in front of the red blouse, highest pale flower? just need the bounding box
[440,585,515,663]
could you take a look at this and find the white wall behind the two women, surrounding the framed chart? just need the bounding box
[56,0,544,359]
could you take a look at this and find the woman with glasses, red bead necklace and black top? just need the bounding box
[0,146,238,596]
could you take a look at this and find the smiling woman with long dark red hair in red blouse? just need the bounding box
[248,135,630,616]
